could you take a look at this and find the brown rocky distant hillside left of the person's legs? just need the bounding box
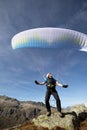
[0,96,46,130]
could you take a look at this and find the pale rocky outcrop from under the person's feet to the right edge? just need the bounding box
[33,105,87,130]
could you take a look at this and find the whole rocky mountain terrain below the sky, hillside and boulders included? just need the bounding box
[0,96,87,130]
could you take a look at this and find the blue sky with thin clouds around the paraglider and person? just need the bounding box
[0,0,87,107]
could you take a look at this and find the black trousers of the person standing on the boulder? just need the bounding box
[45,90,61,112]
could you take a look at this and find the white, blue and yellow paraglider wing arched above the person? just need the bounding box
[11,28,87,51]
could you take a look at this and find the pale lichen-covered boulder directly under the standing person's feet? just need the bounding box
[33,113,76,130]
